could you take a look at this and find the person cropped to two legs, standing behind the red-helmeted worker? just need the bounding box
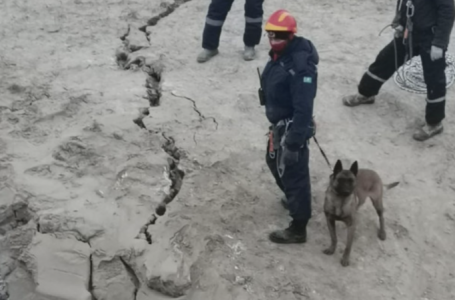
[197,0,264,63]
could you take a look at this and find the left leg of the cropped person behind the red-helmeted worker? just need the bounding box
[197,0,234,62]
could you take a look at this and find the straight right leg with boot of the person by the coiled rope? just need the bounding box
[413,49,446,141]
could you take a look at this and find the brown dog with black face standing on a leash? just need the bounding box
[323,160,399,267]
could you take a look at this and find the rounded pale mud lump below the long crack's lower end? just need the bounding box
[144,247,191,297]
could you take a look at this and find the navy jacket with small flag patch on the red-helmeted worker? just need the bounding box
[261,36,319,151]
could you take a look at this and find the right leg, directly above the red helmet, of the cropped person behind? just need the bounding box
[243,0,264,60]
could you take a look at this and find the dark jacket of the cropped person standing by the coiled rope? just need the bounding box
[394,0,455,50]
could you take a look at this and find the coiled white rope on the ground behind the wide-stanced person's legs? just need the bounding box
[393,53,455,94]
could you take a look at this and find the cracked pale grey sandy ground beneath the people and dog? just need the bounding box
[0,0,455,300]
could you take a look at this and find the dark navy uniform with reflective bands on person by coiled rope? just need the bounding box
[358,0,454,125]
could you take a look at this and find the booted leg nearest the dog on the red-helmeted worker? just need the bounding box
[269,146,311,244]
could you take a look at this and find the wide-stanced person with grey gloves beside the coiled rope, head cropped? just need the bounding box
[342,0,454,141]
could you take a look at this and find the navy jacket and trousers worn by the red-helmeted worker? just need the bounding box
[261,36,319,225]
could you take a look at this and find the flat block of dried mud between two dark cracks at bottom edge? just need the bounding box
[92,251,139,300]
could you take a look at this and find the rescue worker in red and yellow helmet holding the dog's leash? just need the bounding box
[261,10,319,243]
